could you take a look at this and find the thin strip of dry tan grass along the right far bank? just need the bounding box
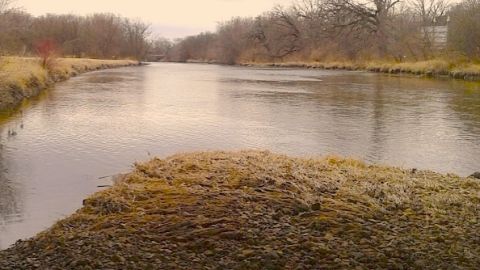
[242,60,480,81]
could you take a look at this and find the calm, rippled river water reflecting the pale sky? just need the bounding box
[0,64,480,249]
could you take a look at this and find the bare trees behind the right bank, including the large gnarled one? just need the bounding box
[152,0,480,64]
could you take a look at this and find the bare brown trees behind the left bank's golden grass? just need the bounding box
[0,0,151,59]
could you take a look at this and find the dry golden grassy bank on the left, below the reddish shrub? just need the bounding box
[0,57,138,111]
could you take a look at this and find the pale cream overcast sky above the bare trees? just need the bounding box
[17,0,293,38]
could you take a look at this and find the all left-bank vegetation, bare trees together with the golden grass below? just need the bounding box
[0,0,150,110]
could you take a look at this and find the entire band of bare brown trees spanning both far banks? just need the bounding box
[0,0,480,64]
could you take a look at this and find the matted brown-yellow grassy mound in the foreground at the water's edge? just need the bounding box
[0,152,480,269]
